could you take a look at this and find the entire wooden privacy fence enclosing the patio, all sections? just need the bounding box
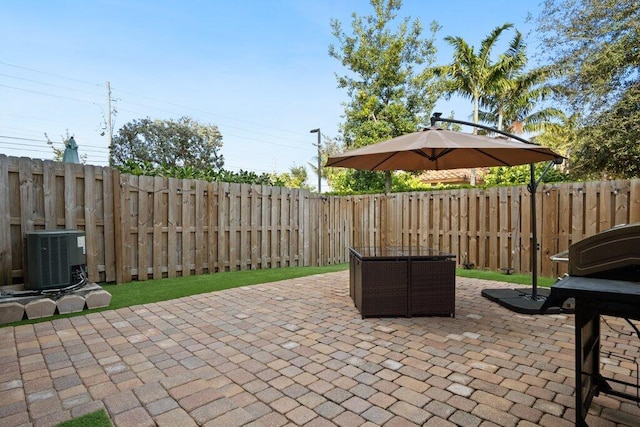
[0,155,640,286]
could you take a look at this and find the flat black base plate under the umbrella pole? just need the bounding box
[482,288,574,314]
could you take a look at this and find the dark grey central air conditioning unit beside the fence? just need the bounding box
[25,230,87,290]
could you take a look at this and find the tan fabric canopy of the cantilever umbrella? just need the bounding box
[326,126,562,171]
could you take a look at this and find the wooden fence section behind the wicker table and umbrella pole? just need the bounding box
[332,180,640,277]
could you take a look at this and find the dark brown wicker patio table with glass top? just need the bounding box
[349,246,456,318]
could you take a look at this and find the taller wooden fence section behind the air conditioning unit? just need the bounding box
[0,155,116,285]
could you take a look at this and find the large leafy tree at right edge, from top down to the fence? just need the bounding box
[537,0,640,179]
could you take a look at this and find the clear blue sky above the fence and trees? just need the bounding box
[0,0,539,183]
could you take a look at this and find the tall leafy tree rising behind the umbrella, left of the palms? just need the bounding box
[329,0,438,191]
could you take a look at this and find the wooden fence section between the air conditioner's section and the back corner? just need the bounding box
[113,172,318,282]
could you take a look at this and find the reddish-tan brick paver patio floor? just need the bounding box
[0,271,640,427]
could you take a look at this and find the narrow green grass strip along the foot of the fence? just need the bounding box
[0,263,555,327]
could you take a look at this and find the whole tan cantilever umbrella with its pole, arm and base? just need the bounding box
[326,123,562,314]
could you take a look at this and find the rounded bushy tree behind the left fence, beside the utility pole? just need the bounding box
[109,117,224,169]
